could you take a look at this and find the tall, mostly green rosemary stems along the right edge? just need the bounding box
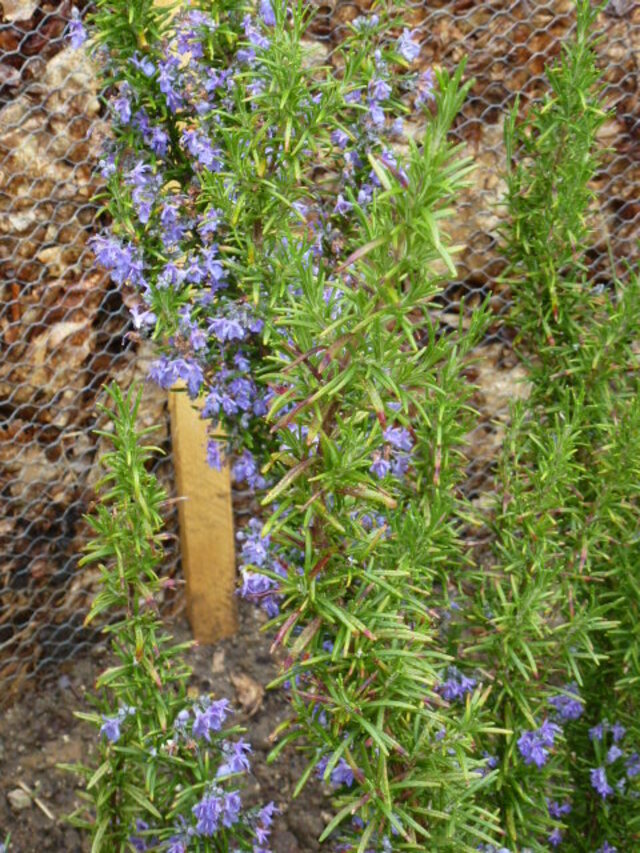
[464,0,640,850]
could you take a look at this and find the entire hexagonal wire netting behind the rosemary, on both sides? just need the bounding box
[0,0,640,696]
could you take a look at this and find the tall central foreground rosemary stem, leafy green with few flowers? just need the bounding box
[256,63,504,850]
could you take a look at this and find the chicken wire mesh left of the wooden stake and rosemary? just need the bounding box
[0,0,177,699]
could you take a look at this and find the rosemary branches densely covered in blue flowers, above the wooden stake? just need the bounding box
[85,0,434,476]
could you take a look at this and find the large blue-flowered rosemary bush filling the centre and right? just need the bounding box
[75,0,640,853]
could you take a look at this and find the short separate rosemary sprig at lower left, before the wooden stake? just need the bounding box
[67,384,275,853]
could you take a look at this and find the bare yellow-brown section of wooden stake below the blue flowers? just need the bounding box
[169,391,238,643]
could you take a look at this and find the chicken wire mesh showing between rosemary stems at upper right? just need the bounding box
[312,0,640,500]
